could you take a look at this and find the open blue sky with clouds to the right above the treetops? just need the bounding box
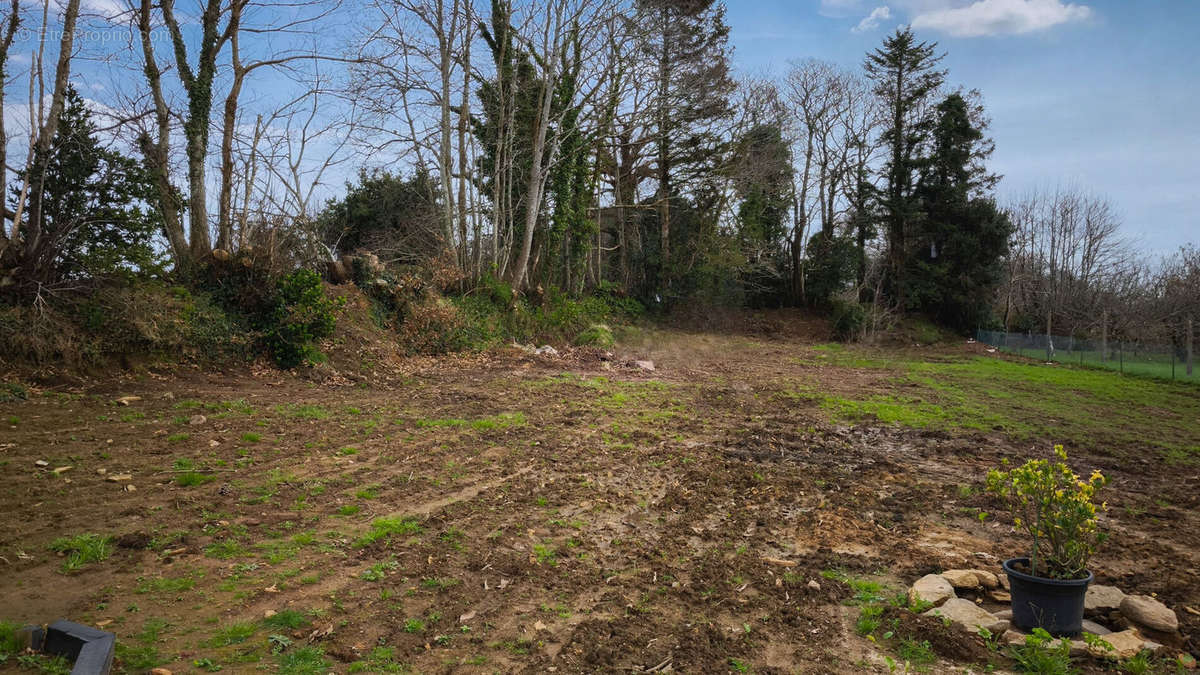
[727,0,1200,253]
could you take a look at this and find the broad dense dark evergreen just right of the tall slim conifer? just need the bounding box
[906,94,1013,330]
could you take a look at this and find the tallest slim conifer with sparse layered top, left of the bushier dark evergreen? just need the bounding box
[864,26,946,305]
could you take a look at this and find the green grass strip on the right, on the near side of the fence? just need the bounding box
[808,345,1200,462]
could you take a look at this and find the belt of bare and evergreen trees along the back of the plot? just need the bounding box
[0,0,1200,360]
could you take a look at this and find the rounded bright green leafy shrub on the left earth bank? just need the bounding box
[266,269,346,368]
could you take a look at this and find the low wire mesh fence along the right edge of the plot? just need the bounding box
[976,330,1200,383]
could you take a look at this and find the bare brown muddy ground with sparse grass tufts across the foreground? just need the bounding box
[0,321,1200,673]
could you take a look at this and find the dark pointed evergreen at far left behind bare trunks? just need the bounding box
[10,85,162,283]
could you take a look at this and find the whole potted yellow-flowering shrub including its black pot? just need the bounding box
[988,446,1108,637]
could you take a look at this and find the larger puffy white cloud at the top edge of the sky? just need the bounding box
[912,0,1092,37]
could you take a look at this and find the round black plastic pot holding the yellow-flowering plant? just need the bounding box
[1004,557,1094,638]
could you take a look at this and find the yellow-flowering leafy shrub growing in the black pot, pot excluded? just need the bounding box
[988,446,1109,579]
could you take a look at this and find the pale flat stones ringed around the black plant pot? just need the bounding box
[908,569,1180,658]
